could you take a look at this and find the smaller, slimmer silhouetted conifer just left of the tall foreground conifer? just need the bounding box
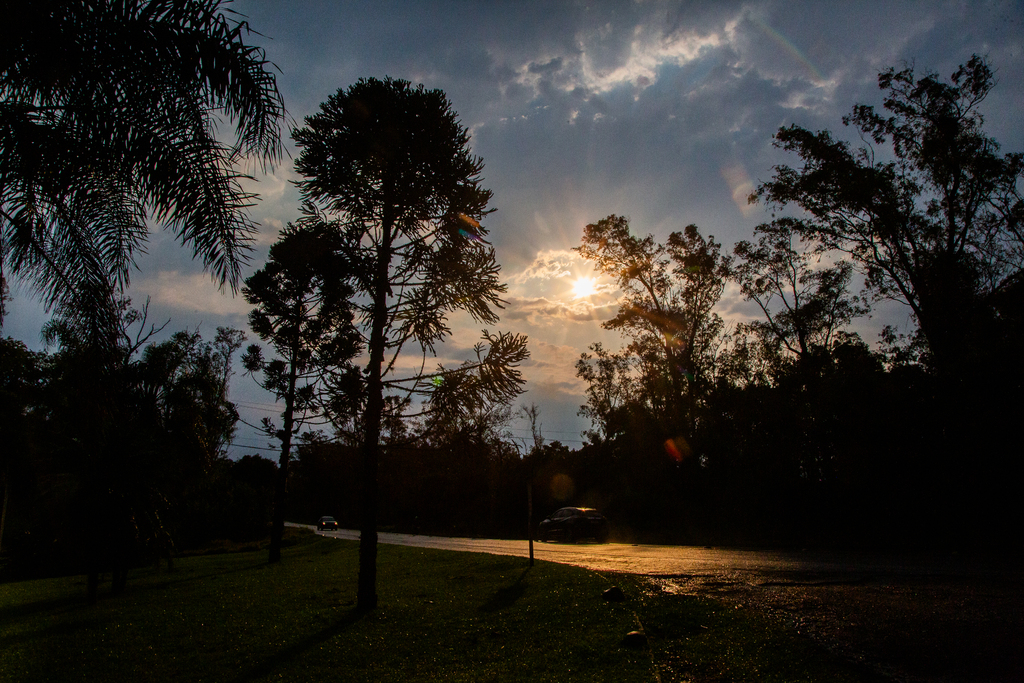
[242,222,359,562]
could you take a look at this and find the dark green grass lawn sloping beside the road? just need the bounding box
[0,532,872,683]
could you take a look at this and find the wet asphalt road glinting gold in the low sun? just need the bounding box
[299,530,1024,683]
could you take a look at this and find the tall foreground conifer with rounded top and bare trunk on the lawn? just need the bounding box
[293,78,528,609]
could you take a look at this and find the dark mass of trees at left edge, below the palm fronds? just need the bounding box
[0,315,275,599]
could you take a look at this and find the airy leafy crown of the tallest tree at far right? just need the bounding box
[753,55,1024,375]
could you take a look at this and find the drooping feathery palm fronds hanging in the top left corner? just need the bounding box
[0,0,285,337]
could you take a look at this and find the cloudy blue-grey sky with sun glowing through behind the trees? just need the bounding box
[3,0,1024,458]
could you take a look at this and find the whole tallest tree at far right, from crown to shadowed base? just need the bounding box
[754,55,1024,543]
